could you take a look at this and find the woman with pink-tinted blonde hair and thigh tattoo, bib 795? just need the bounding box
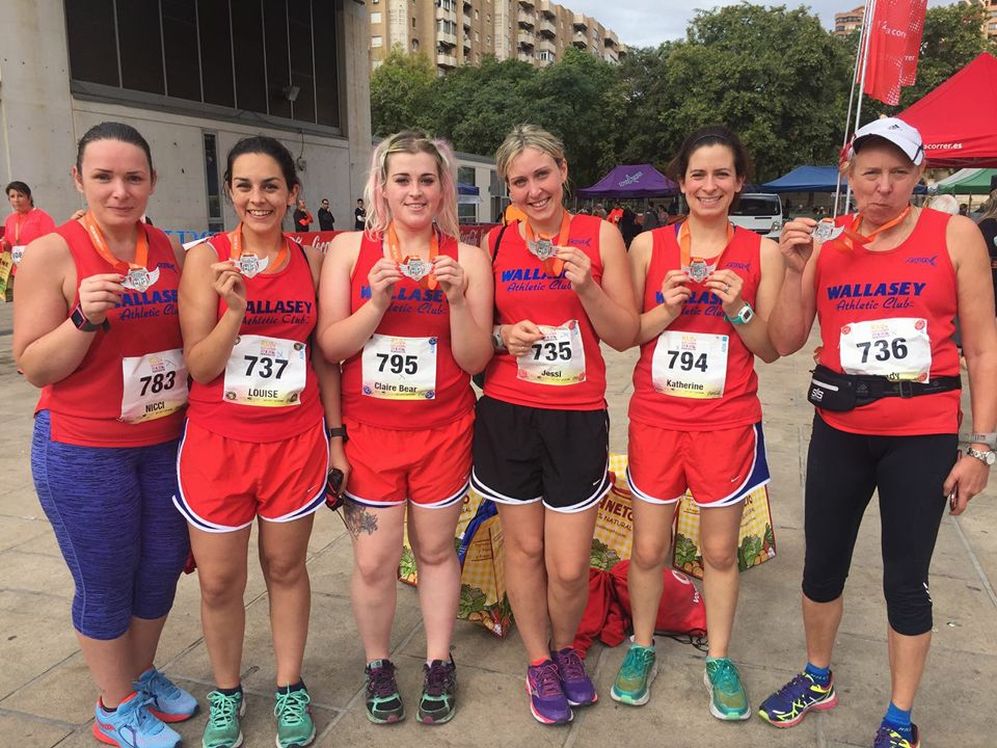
[318,131,492,724]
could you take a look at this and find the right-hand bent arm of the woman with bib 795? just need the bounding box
[441,244,493,374]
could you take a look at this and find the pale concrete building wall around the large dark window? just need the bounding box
[0,0,371,240]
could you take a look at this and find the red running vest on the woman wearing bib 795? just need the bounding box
[343,233,474,431]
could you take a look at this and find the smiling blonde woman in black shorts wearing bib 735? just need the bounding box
[471,125,637,724]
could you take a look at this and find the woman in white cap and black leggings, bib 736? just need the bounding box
[759,118,997,748]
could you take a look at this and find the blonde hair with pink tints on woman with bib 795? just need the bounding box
[364,130,460,237]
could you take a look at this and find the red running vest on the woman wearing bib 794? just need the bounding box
[630,224,762,431]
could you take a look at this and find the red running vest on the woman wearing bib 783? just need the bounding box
[35,221,183,447]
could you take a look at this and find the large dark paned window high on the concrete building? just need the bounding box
[64,0,340,127]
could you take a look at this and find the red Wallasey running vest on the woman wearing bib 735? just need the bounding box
[485,215,606,410]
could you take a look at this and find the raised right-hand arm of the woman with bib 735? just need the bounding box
[568,221,640,351]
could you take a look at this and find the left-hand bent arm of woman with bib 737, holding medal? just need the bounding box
[178,242,246,384]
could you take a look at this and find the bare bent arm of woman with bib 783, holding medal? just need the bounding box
[13,234,121,387]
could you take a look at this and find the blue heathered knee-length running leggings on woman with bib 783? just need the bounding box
[31,411,190,640]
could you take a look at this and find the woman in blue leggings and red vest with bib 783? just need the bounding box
[13,122,197,748]
